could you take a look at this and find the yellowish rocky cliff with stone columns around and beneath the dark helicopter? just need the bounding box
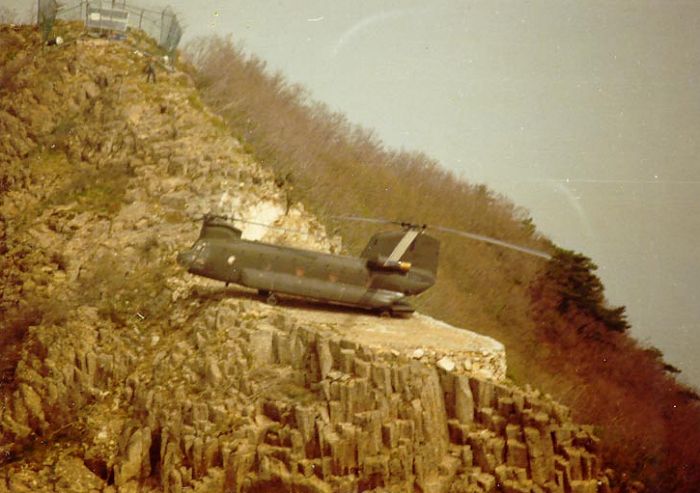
[0,25,609,493]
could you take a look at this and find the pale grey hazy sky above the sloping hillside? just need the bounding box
[8,0,700,387]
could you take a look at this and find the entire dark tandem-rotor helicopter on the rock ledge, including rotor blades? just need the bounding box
[177,214,550,316]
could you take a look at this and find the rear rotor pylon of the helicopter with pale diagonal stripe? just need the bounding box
[361,230,440,276]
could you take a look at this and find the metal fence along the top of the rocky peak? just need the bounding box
[37,0,183,53]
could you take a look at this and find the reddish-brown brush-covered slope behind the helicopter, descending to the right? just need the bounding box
[189,39,700,492]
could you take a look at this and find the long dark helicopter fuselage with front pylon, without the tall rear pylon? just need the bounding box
[178,213,435,313]
